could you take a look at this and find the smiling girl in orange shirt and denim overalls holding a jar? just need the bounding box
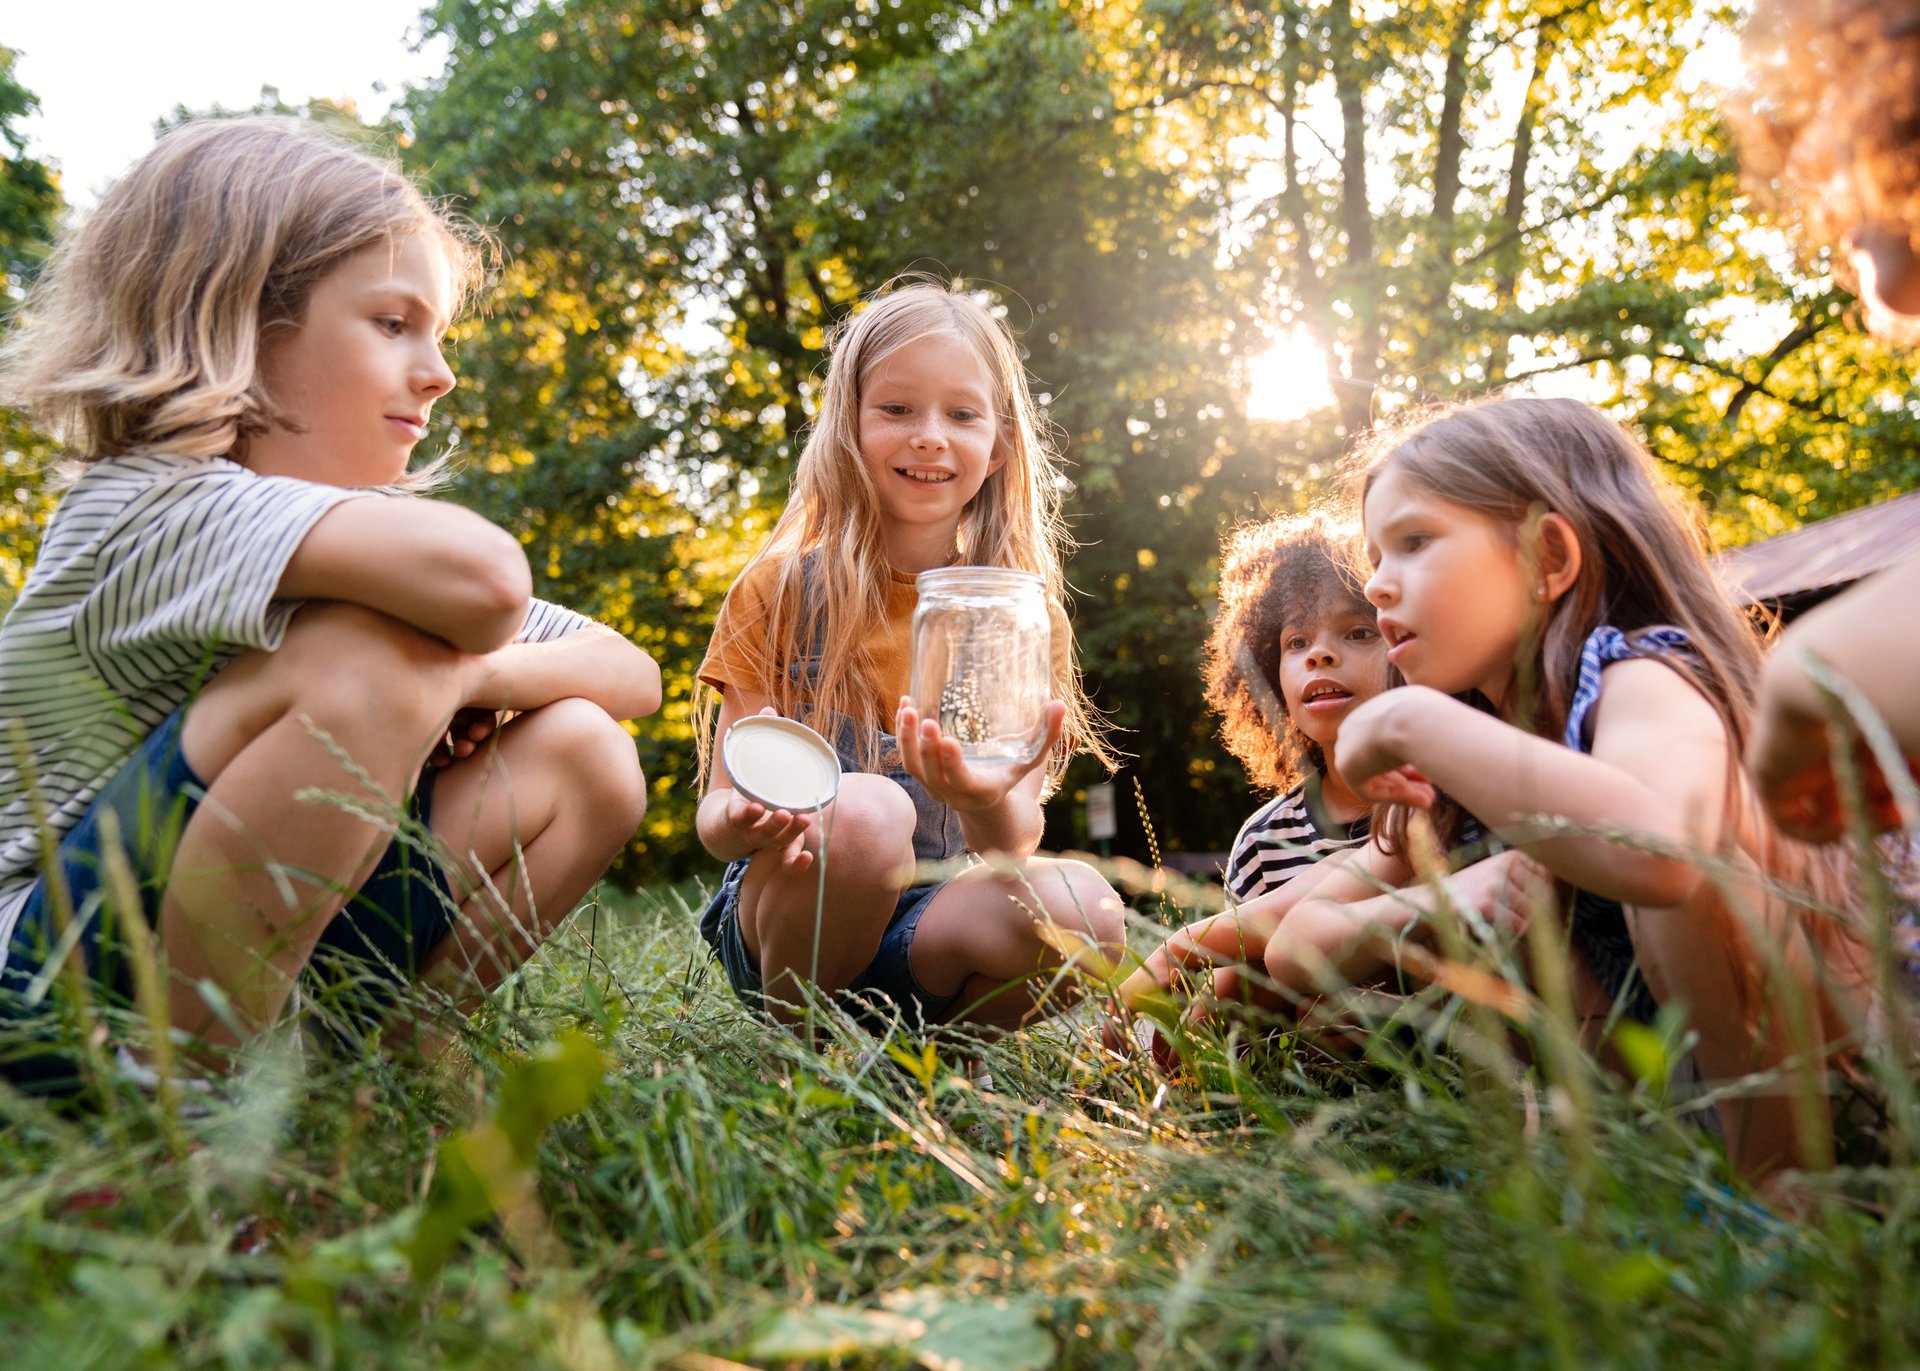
[699,280,1123,1029]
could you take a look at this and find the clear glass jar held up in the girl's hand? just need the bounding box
[908,566,1054,766]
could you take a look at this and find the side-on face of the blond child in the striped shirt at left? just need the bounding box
[246,232,453,486]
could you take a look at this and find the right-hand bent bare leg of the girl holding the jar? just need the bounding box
[908,858,1127,1029]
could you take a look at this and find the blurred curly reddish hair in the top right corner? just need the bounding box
[1726,0,1920,290]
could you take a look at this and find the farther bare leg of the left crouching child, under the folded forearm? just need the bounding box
[424,699,647,1010]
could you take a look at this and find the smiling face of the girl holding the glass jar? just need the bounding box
[860,334,1004,572]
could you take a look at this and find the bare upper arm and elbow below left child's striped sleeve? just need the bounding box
[276,495,534,653]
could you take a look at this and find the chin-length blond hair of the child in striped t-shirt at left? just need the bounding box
[0,119,486,461]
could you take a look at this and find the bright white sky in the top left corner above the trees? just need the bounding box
[0,0,445,207]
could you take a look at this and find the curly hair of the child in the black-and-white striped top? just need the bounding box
[1204,513,1373,791]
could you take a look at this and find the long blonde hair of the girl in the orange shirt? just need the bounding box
[699,275,1116,783]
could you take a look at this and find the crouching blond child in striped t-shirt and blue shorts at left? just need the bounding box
[0,119,660,1091]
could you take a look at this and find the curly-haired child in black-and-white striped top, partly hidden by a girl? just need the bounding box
[1121,515,1386,1004]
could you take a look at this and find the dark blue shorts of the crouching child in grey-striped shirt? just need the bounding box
[0,710,459,1091]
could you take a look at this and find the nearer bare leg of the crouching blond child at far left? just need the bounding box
[159,605,465,1045]
